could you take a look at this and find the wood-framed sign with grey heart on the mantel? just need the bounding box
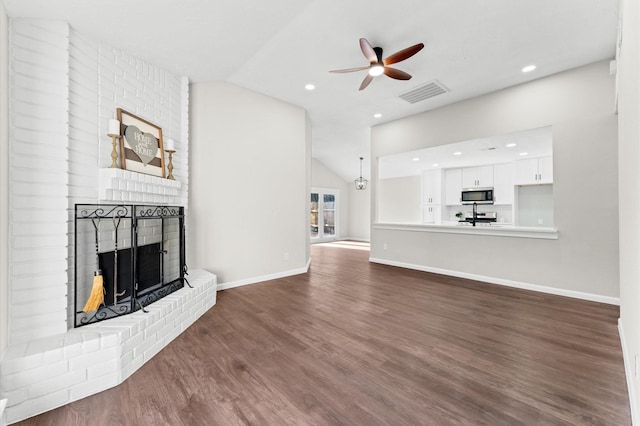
[117,108,165,177]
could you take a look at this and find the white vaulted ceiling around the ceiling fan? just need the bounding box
[4,0,618,180]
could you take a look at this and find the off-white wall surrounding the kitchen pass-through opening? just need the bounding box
[371,61,620,302]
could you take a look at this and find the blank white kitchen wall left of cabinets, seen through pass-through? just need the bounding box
[376,176,422,223]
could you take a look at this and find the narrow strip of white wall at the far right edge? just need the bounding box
[618,0,640,424]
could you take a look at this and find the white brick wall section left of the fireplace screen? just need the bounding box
[9,20,69,345]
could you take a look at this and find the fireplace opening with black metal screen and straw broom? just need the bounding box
[74,204,188,327]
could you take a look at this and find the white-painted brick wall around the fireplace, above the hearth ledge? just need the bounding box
[9,20,188,344]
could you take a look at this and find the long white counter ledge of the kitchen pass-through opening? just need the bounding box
[372,221,558,240]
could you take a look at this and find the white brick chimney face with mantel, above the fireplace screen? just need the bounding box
[67,31,189,327]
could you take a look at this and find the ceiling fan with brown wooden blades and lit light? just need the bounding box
[329,38,424,90]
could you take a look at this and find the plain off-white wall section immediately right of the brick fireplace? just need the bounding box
[187,82,310,288]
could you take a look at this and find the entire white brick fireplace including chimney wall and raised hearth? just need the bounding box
[0,20,216,423]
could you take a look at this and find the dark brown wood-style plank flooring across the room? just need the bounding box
[21,246,631,425]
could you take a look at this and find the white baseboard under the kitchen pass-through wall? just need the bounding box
[369,257,620,305]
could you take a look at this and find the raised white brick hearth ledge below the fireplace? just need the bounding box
[0,269,217,424]
